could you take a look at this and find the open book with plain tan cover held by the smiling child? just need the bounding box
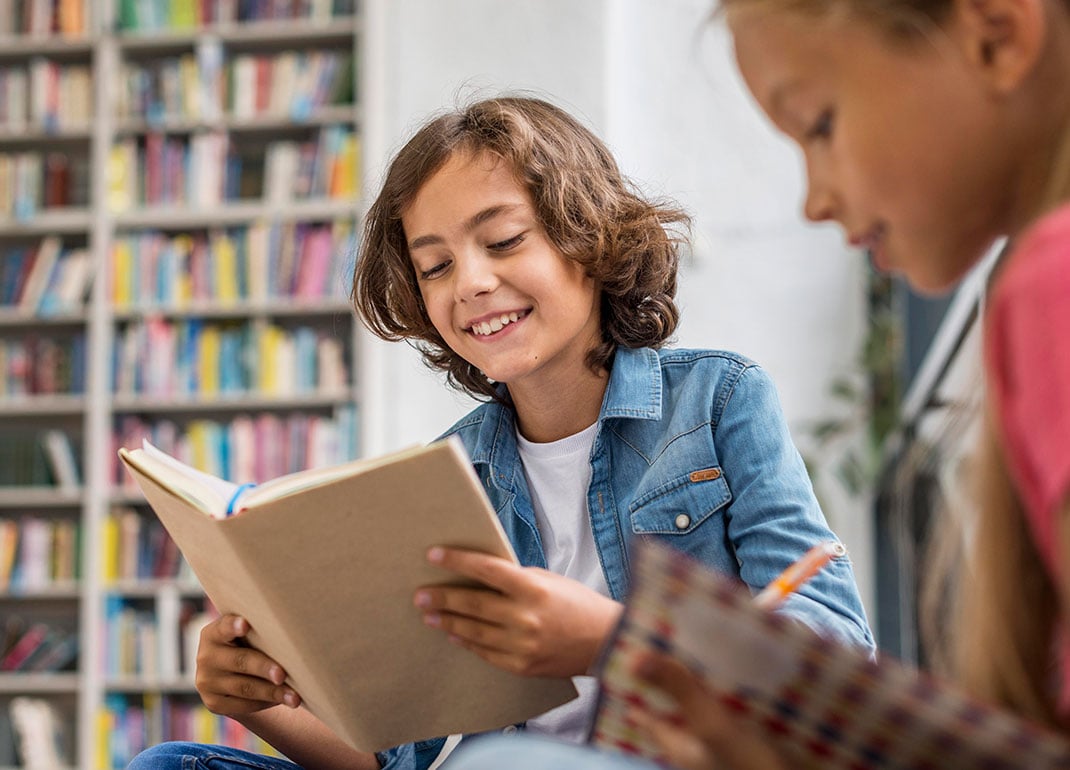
[119,437,576,751]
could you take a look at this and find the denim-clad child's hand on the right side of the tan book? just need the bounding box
[414,548,622,677]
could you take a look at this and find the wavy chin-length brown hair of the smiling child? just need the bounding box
[352,96,690,398]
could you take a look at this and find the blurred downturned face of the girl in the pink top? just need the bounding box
[728,6,1014,291]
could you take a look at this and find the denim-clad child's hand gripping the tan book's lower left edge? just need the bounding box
[196,615,301,717]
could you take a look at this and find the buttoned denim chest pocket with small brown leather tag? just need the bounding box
[628,467,732,535]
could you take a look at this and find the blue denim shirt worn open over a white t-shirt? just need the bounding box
[379,349,873,770]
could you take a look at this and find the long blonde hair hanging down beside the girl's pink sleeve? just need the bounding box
[921,414,1060,727]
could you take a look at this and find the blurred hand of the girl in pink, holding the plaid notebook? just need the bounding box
[630,652,788,770]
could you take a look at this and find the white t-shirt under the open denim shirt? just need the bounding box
[517,422,610,743]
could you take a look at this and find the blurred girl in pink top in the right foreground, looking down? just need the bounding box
[458,0,1070,769]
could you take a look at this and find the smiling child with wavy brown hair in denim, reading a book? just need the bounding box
[135,98,872,768]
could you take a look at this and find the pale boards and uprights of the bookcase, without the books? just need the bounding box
[0,0,367,770]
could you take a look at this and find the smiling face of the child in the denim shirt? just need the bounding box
[401,153,600,399]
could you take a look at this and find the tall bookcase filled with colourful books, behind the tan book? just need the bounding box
[0,0,364,770]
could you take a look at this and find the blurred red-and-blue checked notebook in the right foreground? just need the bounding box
[592,542,1070,770]
